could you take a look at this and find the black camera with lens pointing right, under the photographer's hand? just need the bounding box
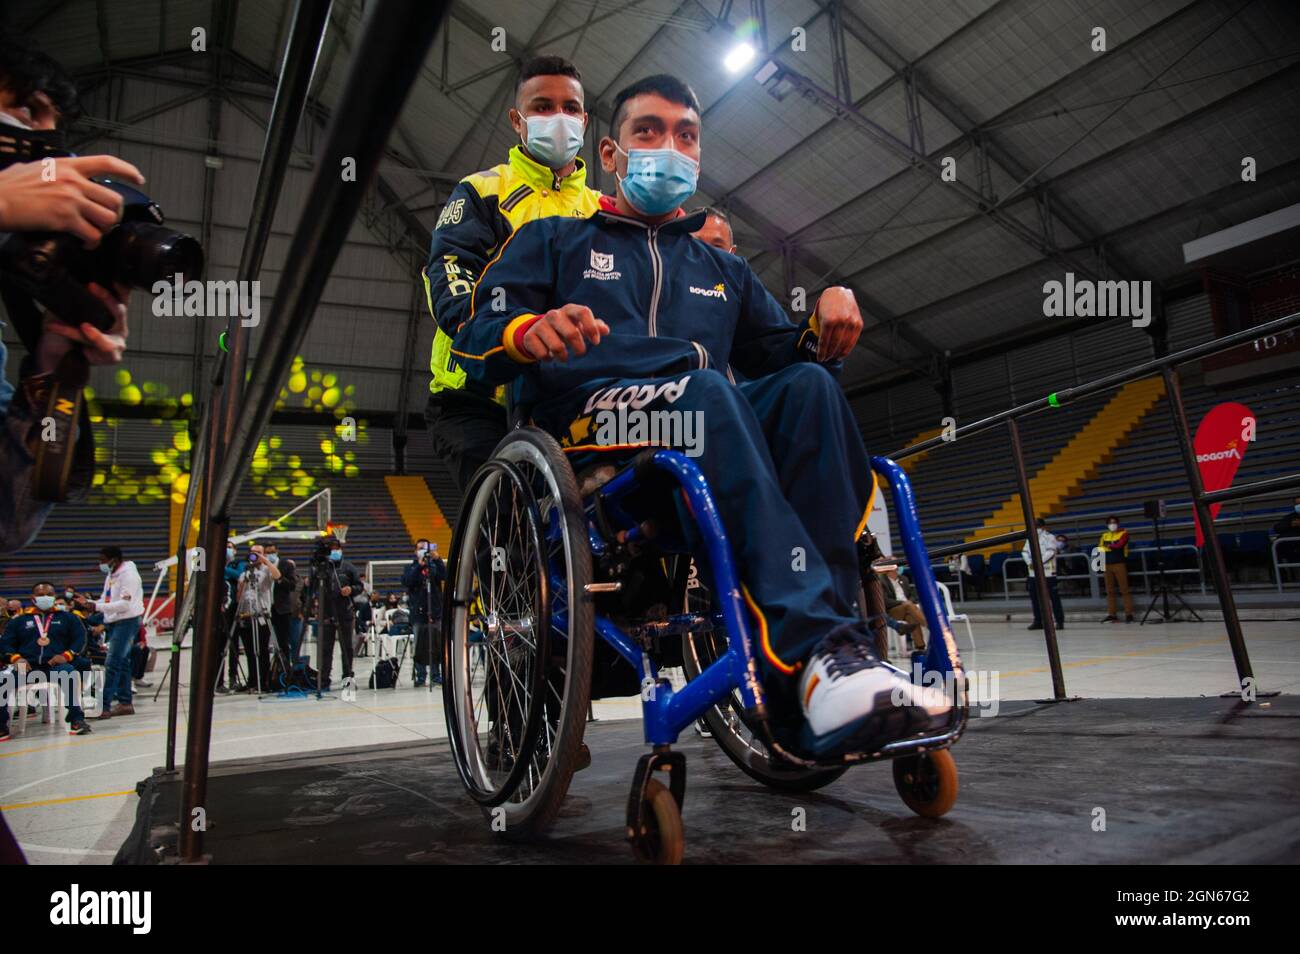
[0,178,203,331]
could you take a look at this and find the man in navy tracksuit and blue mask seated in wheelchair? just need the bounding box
[454,75,950,758]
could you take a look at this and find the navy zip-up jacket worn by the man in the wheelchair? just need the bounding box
[454,201,826,400]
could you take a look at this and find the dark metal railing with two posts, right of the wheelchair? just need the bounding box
[889,306,1300,701]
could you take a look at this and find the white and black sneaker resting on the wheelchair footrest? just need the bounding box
[800,624,952,758]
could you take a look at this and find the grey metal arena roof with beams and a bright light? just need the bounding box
[5,0,1300,413]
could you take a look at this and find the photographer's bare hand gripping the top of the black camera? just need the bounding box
[0,156,144,248]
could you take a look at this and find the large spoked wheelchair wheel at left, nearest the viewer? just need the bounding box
[443,428,593,836]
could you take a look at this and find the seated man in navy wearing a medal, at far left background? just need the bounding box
[0,582,90,741]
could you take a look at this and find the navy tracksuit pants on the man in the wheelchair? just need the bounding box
[534,363,874,716]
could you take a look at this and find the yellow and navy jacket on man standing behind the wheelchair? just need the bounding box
[424,146,601,399]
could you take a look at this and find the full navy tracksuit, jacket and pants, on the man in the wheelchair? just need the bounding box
[455,205,874,714]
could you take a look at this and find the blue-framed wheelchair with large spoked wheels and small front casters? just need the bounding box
[443,424,967,864]
